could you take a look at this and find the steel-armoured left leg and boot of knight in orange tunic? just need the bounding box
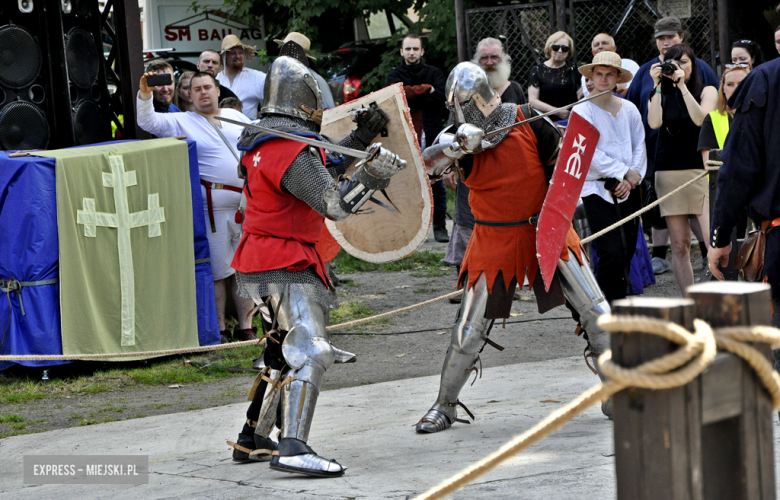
[415,274,490,433]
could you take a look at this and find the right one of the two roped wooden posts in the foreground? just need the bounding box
[687,282,775,500]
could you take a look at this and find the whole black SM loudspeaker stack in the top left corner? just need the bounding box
[0,0,111,150]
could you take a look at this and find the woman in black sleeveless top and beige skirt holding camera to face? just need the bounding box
[647,43,718,293]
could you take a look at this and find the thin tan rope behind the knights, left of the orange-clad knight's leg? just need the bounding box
[0,289,463,361]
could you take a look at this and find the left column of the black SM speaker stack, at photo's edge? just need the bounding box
[0,0,54,150]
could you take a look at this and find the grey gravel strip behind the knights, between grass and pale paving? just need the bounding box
[0,224,702,438]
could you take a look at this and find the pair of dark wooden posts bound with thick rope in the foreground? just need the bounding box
[612,282,775,500]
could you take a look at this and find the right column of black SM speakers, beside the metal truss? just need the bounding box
[55,0,111,146]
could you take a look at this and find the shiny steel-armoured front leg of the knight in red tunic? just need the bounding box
[266,292,346,477]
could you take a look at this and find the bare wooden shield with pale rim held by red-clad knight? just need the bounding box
[322,83,433,263]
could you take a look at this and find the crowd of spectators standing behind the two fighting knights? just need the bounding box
[138,17,780,334]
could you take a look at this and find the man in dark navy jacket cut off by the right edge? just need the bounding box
[707,59,780,370]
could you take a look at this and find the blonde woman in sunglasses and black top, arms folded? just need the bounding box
[528,31,582,120]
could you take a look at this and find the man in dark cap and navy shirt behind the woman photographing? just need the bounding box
[626,17,719,274]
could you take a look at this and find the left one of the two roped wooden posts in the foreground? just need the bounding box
[612,298,703,500]
